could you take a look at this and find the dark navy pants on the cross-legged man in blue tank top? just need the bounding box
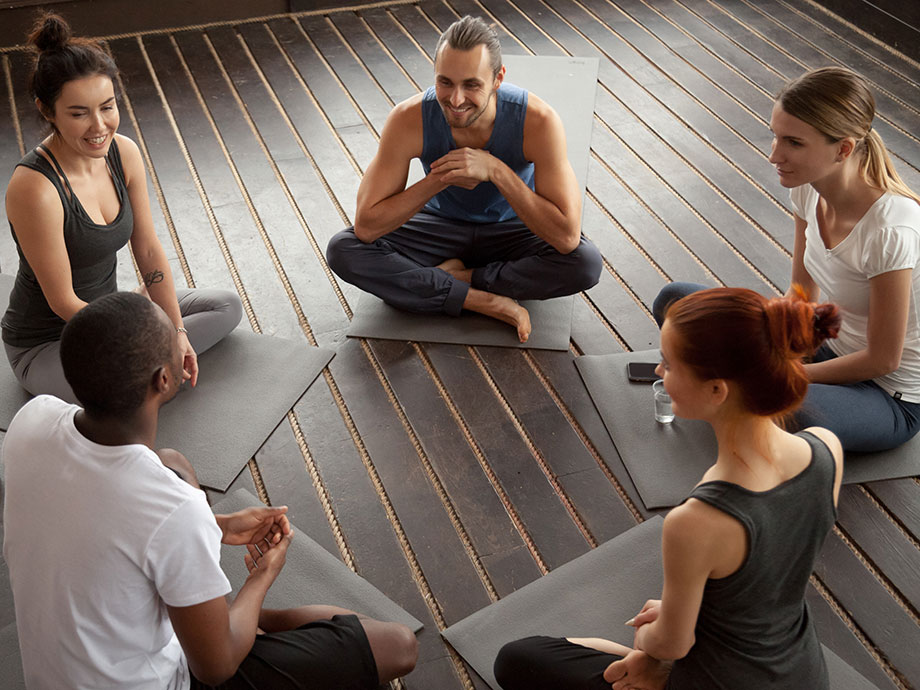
[326,212,602,316]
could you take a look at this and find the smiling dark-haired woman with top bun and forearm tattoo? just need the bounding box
[2,13,242,402]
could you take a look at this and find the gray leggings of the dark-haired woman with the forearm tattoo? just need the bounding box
[4,289,243,404]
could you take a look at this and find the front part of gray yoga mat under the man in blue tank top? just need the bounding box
[347,293,573,350]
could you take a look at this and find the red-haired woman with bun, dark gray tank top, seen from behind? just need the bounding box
[495,288,843,690]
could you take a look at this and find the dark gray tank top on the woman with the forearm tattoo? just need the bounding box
[0,140,134,347]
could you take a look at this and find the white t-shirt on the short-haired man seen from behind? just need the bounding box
[3,395,230,690]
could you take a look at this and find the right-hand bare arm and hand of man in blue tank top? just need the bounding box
[431,94,581,254]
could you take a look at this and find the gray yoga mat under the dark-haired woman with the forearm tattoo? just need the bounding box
[0,274,335,484]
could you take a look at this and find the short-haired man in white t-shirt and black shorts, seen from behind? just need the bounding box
[3,293,416,690]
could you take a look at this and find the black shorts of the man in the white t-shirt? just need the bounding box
[191,615,379,690]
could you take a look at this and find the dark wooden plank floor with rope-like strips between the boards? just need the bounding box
[0,0,920,690]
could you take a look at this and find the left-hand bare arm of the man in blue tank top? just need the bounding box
[355,94,447,242]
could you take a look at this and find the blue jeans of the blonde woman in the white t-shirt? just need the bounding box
[652,283,920,452]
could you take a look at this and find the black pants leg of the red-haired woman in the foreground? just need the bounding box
[493,636,623,690]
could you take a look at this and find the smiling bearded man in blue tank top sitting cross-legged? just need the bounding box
[326,16,601,342]
